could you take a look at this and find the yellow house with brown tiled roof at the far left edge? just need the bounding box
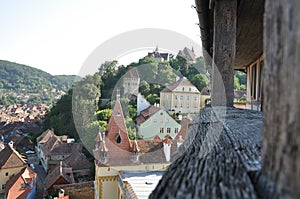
[0,146,27,193]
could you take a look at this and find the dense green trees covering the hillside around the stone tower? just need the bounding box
[44,53,246,146]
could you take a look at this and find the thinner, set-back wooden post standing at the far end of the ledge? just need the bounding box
[212,0,237,106]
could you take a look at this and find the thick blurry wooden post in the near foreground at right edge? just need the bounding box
[263,0,300,198]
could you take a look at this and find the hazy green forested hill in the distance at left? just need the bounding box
[0,60,79,104]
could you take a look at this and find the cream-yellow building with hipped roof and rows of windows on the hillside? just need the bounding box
[160,77,201,113]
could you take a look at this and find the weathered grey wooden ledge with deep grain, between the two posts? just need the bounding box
[150,107,262,198]
